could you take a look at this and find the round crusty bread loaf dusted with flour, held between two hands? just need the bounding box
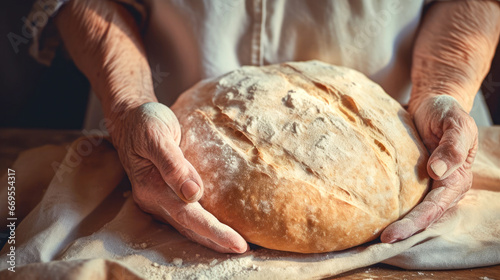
[172,61,429,253]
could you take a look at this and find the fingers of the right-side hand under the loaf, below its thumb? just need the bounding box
[380,166,472,243]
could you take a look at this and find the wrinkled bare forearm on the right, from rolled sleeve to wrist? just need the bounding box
[409,1,500,113]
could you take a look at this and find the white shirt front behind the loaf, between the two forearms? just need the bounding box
[25,0,488,128]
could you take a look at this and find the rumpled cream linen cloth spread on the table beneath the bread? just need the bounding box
[0,126,500,279]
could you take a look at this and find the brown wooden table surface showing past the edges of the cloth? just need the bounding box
[0,128,500,280]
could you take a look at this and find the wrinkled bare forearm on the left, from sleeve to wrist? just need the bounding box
[55,0,157,122]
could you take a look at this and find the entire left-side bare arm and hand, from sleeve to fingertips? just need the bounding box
[56,0,248,253]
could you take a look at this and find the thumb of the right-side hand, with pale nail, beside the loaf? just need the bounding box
[427,125,475,180]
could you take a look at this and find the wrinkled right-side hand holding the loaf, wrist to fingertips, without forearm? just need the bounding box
[381,95,478,243]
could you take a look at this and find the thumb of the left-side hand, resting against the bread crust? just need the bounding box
[149,139,203,202]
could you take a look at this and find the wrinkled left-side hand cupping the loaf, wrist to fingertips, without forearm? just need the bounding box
[111,103,248,253]
